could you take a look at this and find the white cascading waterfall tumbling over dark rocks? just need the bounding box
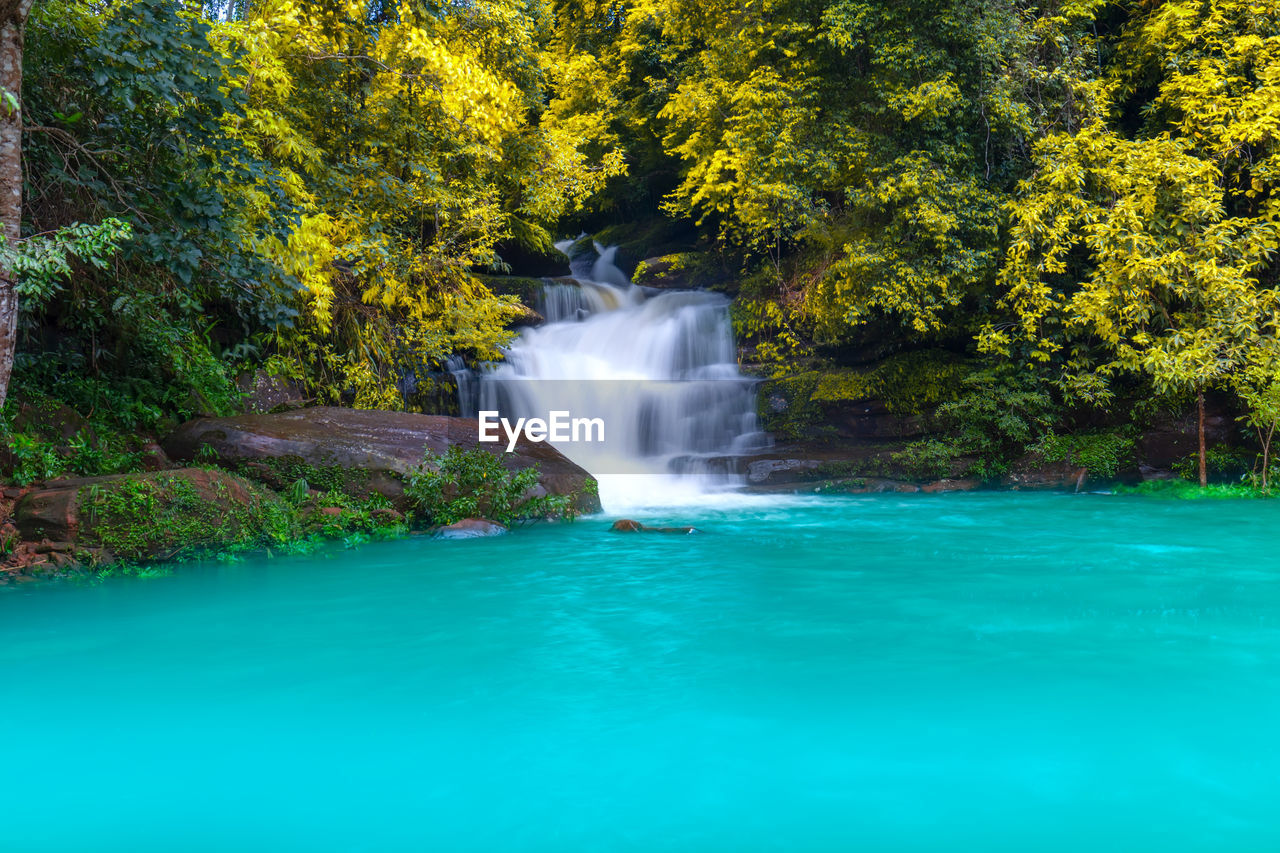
[471,236,769,504]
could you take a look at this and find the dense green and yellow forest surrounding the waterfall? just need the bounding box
[0,0,1280,482]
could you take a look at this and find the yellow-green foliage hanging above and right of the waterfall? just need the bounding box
[553,0,1101,350]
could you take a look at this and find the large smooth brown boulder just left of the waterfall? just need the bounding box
[164,406,600,512]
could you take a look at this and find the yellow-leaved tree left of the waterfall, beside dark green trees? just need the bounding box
[208,0,621,407]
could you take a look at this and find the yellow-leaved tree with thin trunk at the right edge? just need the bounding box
[982,0,1280,485]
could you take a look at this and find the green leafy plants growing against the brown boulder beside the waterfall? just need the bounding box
[404,444,575,525]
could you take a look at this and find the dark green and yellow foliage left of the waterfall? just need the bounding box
[17,0,625,428]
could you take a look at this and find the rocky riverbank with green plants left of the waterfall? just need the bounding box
[0,407,600,583]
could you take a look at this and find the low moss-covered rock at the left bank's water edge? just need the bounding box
[14,467,275,560]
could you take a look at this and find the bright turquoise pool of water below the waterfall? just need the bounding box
[0,494,1280,852]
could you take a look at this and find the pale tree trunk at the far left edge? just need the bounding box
[0,0,32,407]
